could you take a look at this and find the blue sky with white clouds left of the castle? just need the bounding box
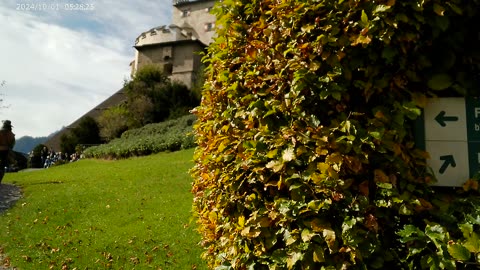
[0,0,172,139]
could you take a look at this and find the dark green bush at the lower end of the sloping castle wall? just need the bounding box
[60,116,102,153]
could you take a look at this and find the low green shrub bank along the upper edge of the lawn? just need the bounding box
[83,115,196,158]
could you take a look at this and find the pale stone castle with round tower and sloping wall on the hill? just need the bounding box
[44,0,215,151]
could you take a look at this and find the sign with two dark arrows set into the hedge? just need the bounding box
[416,98,480,187]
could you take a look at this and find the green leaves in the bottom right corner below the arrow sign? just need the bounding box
[398,192,480,269]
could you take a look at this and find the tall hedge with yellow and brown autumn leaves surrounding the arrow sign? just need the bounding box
[191,0,480,269]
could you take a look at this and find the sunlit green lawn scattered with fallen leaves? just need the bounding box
[0,149,206,269]
